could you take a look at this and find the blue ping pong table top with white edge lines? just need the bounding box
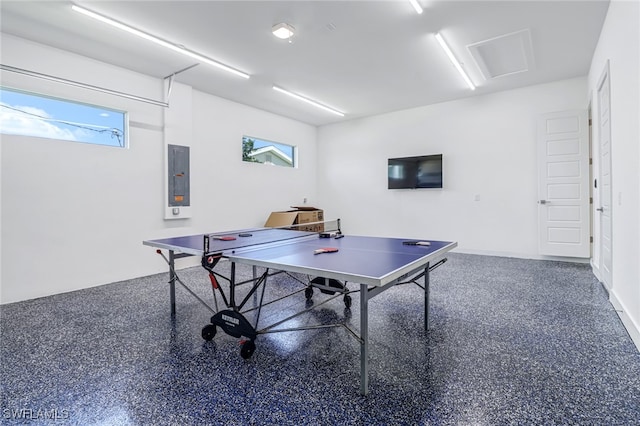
[144,228,457,286]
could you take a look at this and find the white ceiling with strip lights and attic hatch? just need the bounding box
[0,0,609,125]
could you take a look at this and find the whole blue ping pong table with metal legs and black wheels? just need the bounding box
[143,220,457,395]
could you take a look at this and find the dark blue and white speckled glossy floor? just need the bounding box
[0,253,640,425]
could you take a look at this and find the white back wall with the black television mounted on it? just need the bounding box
[318,75,588,258]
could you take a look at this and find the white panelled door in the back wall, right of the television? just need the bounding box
[537,110,591,258]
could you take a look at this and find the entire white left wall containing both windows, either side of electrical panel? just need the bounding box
[0,34,316,303]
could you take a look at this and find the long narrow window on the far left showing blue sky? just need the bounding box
[0,87,127,148]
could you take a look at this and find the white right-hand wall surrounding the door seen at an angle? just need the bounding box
[588,1,640,348]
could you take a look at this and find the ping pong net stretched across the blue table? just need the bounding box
[202,219,342,255]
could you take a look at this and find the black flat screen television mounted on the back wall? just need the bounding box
[387,154,442,189]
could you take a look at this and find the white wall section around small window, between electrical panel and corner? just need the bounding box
[192,92,317,230]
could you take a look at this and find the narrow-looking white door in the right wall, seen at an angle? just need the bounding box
[596,66,613,289]
